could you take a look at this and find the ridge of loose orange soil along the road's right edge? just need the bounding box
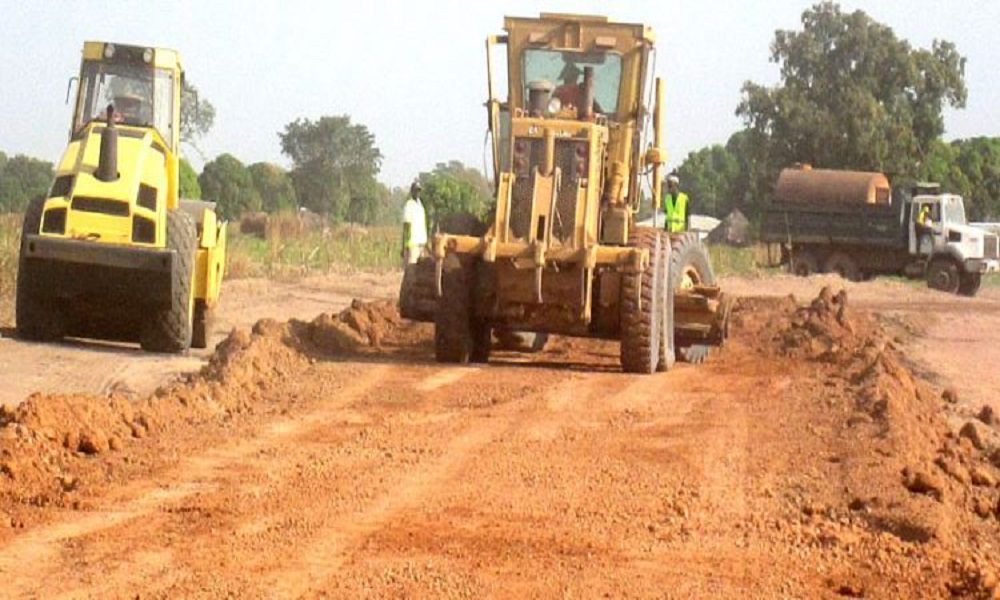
[734,288,1000,597]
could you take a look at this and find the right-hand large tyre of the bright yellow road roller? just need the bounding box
[140,210,198,352]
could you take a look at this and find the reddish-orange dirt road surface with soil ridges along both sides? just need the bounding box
[0,279,1000,598]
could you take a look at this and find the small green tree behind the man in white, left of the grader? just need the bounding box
[419,160,493,229]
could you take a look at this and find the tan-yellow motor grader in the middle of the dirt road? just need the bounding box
[400,13,730,373]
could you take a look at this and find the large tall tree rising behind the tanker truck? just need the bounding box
[736,2,967,201]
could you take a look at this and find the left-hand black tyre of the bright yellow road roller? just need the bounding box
[14,198,65,342]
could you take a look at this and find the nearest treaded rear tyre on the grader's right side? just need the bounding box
[619,227,665,373]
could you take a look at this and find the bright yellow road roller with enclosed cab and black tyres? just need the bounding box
[15,42,226,352]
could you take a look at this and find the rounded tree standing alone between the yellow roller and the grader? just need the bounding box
[278,115,382,223]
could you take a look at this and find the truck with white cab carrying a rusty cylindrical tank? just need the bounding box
[761,165,1000,296]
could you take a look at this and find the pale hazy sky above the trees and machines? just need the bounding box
[0,0,1000,185]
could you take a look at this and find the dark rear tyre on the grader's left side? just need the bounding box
[434,254,472,363]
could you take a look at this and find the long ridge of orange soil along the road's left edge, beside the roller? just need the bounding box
[0,300,404,520]
